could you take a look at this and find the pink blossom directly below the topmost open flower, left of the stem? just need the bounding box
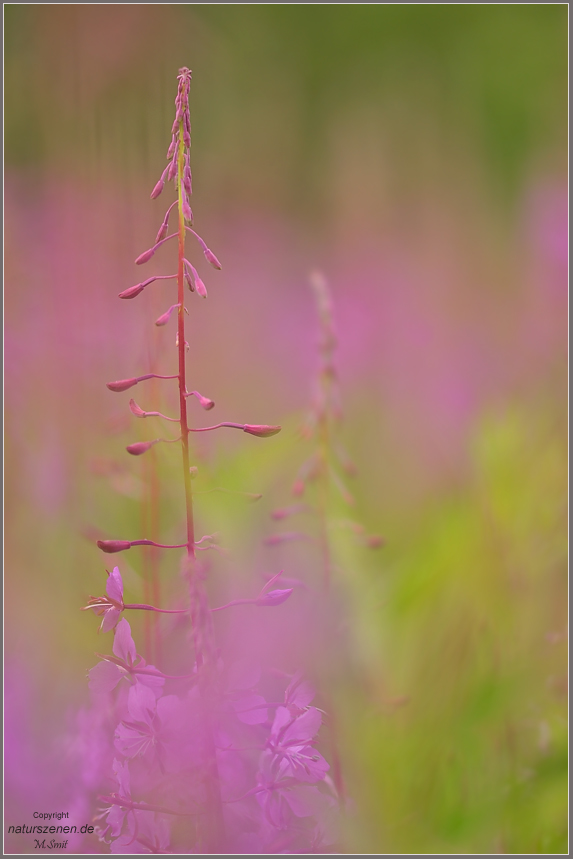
[88,618,165,696]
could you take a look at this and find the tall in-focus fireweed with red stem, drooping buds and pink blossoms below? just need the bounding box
[85,68,337,853]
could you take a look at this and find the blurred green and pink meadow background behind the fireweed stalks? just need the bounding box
[4,4,567,853]
